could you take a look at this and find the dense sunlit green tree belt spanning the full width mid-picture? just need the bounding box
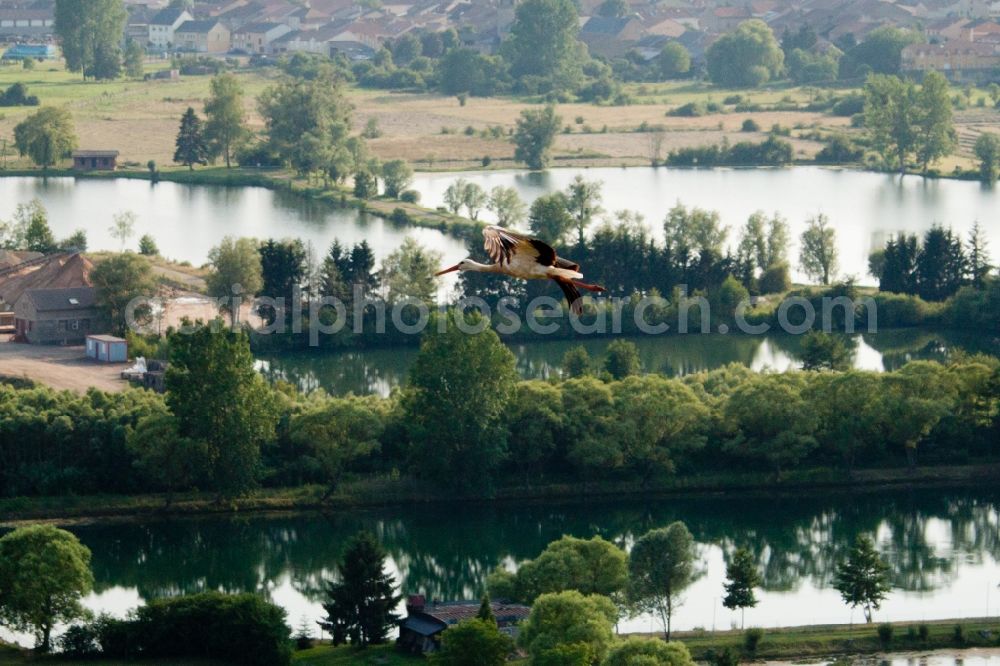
[0,321,1000,496]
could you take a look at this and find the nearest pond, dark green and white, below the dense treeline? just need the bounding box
[1,488,1000,644]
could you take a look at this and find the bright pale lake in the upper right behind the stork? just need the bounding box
[414,166,1000,283]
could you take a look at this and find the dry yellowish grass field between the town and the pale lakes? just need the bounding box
[0,61,1000,172]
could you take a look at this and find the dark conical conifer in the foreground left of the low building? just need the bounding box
[320,531,401,647]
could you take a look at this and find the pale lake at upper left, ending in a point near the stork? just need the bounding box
[0,178,466,265]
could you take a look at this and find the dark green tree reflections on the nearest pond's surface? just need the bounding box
[74,491,1000,600]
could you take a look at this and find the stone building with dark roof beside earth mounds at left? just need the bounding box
[14,287,107,345]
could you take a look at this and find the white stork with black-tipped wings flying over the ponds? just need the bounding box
[436,225,604,314]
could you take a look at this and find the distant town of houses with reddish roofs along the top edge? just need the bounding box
[0,0,1000,81]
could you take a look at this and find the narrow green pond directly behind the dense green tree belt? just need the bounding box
[260,329,1000,395]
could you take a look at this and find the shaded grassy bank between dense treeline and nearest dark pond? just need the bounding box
[0,463,1000,527]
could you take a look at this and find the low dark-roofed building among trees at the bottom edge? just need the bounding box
[396,594,531,654]
